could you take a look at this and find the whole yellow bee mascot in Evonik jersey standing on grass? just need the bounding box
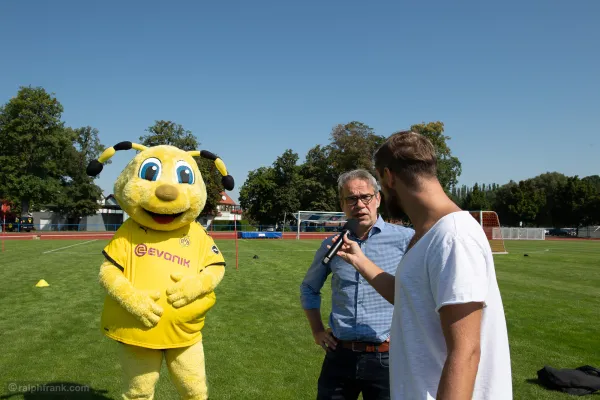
[87,142,234,400]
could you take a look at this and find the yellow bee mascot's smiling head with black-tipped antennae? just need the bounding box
[86,142,234,231]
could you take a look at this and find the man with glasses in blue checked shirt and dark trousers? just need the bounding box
[300,169,414,400]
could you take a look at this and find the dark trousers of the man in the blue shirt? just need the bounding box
[317,346,390,400]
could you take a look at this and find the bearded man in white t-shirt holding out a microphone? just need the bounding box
[338,132,512,400]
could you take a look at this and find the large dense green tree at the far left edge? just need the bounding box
[0,87,72,214]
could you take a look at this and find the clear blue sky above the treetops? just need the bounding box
[0,0,600,203]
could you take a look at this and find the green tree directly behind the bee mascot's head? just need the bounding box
[139,120,227,214]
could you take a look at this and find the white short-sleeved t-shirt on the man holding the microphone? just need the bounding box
[390,211,512,400]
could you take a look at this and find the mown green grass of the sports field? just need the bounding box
[0,240,600,400]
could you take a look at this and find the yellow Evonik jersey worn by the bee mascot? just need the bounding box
[101,219,225,349]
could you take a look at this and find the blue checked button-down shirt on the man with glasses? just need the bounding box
[300,216,414,342]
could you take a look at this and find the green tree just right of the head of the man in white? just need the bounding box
[410,121,462,193]
